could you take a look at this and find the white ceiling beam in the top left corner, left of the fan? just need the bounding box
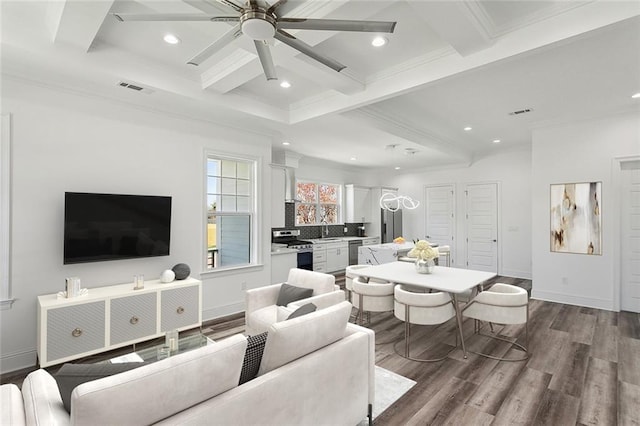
[48,0,114,52]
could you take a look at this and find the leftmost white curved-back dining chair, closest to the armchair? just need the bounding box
[351,277,395,324]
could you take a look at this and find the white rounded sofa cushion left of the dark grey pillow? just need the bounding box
[22,369,69,425]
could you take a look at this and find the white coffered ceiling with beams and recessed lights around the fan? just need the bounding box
[1,0,640,170]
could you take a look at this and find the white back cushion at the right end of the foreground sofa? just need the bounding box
[258,301,352,376]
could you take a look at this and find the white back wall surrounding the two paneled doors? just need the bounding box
[384,150,531,278]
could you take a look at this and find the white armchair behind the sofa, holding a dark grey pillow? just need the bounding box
[244,268,346,336]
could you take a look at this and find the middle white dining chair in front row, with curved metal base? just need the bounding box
[394,285,458,362]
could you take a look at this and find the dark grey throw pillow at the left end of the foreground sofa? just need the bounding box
[54,362,145,412]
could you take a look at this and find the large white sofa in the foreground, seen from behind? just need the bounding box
[0,302,375,426]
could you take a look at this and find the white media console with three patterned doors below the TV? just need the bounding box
[37,278,202,367]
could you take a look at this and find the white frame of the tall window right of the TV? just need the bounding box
[201,149,262,275]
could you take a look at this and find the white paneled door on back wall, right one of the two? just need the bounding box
[465,183,498,273]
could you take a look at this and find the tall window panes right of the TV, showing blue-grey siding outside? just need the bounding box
[206,155,257,270]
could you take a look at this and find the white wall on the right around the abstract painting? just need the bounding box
[532,112,640,310]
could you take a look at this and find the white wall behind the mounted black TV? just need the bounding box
[0,79,271,371]
